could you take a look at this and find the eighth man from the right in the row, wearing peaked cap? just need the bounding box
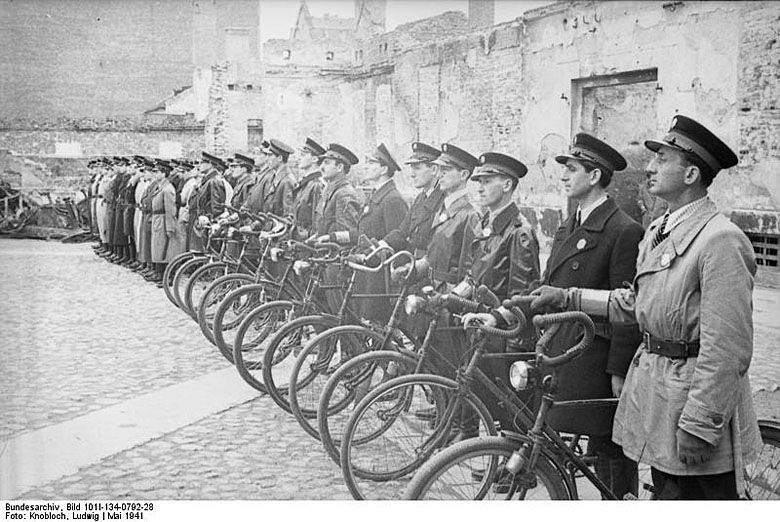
[293,138,325,239]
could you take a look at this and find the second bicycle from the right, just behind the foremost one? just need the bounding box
[340,294,536,500]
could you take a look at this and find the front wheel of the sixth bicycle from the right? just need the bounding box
[233,301,300,393]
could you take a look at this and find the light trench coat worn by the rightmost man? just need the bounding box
[609,200,761,480]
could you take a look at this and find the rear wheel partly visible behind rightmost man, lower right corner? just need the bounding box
[745,420,780,500]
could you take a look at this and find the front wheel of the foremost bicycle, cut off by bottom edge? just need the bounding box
[403,436,570,500]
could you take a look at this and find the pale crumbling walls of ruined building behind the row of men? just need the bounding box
[0,0,780,266]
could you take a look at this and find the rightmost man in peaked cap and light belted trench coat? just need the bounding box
[532,116,761,500]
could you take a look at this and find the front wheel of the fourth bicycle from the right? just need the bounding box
[288,325,408,440]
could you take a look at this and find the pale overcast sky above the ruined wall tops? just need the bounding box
[260,0,553,41]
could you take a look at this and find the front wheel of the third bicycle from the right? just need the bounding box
[317,350,419,464]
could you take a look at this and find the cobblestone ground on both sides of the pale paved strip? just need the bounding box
[0,240,780,499]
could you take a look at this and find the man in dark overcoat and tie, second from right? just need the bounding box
[542,133,644,498]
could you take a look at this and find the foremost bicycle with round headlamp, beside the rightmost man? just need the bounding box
[403,300,780,500]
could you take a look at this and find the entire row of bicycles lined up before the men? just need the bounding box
[163,206,780,499]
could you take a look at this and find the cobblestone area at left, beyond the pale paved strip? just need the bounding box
[0,238,227,441]
